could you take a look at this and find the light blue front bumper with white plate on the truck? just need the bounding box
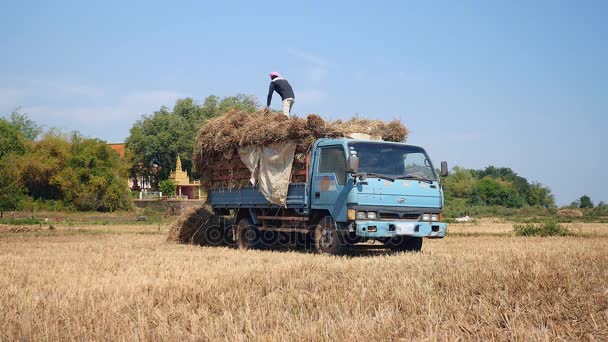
[349,220,448,239]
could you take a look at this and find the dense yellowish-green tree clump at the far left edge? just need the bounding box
[0,111,133,214]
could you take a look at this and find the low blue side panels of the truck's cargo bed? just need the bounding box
[209,182,308,209]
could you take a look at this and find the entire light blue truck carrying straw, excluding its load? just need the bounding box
[209,138,448,254]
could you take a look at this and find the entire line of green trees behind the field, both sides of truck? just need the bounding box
[0,94,604,211]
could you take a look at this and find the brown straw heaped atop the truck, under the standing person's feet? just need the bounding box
[193,110,408,173]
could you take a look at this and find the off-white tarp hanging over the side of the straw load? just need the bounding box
[239,141,296,206]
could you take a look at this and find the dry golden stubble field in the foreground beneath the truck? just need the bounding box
[0,225,608,341]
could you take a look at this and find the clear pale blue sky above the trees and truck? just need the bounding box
[0,1,608,204]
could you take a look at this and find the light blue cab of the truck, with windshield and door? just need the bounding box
[310,139,447,251]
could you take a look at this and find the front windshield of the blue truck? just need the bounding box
[348,142,437,181]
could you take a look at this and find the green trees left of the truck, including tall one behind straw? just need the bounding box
[0,95,257,216]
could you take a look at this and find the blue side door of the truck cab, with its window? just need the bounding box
[310,146,346,222]
